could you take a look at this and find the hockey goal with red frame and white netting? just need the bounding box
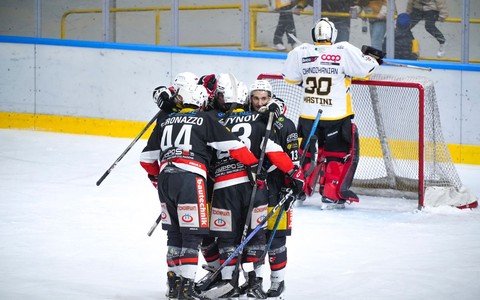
[258,74,477,208]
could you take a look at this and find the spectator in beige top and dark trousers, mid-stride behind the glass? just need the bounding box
[407,0,448,57]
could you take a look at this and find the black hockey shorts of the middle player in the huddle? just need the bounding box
[210,182,268,238]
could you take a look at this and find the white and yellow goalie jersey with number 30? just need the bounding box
[283,42,378,120]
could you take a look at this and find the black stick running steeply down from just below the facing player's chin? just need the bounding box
[196,112,275,290]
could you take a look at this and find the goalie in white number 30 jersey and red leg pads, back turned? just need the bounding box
[283,18,382,208]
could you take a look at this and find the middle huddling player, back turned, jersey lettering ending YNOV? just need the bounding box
[204,74,303,299]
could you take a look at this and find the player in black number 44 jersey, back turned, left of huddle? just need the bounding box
[140,84,258,299]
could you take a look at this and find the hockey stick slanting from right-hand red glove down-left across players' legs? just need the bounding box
[196,189,293,299]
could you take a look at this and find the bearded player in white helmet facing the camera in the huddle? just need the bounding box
[249,80,299,299]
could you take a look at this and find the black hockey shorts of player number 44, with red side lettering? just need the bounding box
[158,172,209,234]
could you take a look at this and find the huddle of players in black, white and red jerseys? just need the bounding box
[141,72,304,299]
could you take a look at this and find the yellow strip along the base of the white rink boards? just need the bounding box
[0,112,480,165]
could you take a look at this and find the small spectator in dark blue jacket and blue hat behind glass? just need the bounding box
[383,13,419,60]
